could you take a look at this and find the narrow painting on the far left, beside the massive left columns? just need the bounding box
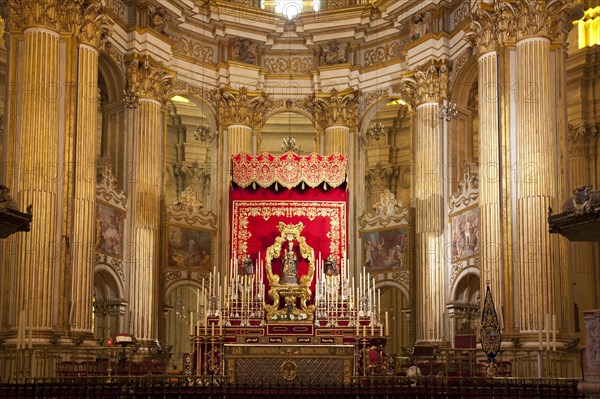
[96,203,125,259]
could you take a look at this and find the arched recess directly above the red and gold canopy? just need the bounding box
[258,111,319,155]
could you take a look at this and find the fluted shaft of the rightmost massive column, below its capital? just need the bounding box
[515,37,560,332]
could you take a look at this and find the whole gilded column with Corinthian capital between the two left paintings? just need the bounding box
[126,53,172,346]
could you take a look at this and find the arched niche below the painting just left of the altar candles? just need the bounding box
[164,281,204,370]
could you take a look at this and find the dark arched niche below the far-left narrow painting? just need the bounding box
[93,265,128,343]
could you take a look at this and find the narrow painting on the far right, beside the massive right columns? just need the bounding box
[451,206,480,261]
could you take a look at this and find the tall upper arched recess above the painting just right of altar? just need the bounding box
[360,97,413,210]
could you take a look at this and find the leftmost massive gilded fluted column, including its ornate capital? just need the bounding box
[3,2,62,344]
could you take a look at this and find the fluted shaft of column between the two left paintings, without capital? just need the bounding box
[130,98,163,342]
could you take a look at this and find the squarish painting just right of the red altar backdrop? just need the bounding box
[363,227,410,272]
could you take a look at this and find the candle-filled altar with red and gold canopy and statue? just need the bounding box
[187,152,388,384]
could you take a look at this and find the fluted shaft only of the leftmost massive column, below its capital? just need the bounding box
[10,27,60,331]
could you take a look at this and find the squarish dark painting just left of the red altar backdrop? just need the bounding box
[167,225,212,270]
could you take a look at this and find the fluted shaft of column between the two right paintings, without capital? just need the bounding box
[414,102,444,341]
